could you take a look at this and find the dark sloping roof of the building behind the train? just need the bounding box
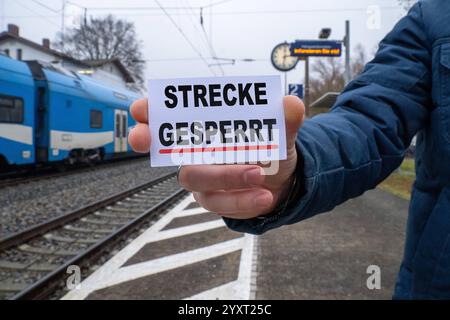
[0,31,135,83]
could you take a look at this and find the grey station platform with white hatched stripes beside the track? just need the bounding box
[63,190,408,300]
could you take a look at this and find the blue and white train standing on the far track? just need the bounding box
[0,55,139,169]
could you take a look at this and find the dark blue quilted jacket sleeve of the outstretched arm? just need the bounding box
[225,2,431,234]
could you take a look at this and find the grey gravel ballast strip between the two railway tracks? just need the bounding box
[0,158,174,238]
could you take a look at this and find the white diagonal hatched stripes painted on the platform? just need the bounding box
[63,195,256,300]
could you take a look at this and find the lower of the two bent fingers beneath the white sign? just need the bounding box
[195,188,274,219]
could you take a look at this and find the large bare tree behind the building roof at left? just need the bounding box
[55,15,145,86]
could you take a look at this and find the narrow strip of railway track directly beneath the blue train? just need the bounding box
[0,157,146,189]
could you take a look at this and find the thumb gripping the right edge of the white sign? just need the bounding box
[284,96,305,150]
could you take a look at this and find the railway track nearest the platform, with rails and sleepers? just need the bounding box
[0,173,185,300]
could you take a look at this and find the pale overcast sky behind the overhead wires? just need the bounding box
[0,0,404,83]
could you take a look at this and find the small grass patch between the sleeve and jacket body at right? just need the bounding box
[378,159,416,200]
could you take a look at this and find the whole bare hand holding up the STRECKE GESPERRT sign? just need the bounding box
[129,96,305,219]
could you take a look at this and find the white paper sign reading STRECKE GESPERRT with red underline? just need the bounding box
[148,76,286,167]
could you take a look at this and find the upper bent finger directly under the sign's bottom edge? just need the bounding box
[179,165,265,192]
